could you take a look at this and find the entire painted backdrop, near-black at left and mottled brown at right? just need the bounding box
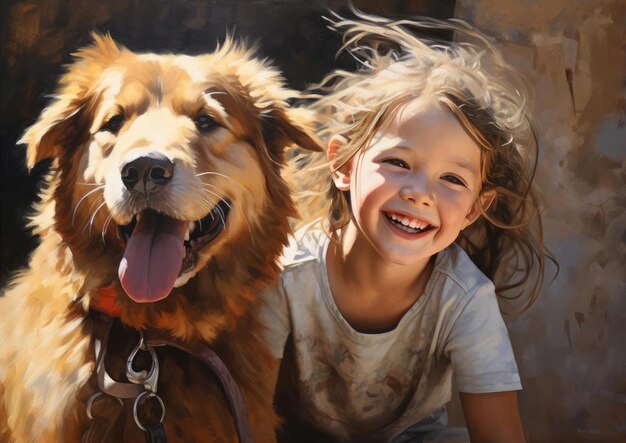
[0,0,626,442]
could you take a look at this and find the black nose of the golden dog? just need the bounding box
[122,153,174,193]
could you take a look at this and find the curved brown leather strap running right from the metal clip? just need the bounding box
[144,329,254,443]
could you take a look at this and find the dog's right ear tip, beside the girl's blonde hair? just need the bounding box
[262,106,323,152]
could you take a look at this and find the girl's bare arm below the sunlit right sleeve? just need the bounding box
[461,391,526,443]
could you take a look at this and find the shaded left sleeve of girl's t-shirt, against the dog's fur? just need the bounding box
[260,279,291,358]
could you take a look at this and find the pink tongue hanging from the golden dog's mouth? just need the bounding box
[118,211,188,303]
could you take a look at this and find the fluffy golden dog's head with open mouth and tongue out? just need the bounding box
[22,36,320,332]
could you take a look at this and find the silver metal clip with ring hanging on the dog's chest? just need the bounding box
[126,330,165,432]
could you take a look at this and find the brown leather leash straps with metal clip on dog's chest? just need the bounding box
[82,306,254,443]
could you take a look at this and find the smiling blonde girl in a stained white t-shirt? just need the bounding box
[264,14,545,443]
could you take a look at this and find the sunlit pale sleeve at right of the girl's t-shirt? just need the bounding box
[444,283,522,393]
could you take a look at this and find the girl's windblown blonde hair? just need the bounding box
[294,11,550,308]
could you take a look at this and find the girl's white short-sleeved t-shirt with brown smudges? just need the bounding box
[262,231,521,440]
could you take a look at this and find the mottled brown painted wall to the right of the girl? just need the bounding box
[444,0,626,442]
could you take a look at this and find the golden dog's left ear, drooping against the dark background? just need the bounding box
[18,34,122,169]
